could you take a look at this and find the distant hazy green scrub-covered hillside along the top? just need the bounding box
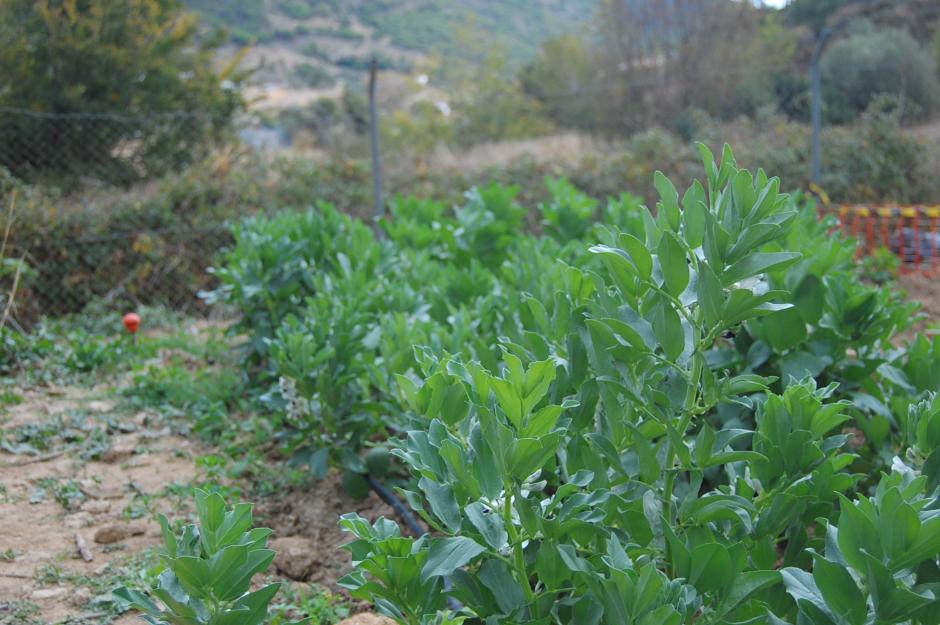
[184,0,597,88]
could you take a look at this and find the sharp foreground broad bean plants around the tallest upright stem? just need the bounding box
[341,146,940,625]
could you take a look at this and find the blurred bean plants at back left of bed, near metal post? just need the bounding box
[210,178,595,491]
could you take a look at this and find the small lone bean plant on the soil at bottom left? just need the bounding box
[114,491,304,625]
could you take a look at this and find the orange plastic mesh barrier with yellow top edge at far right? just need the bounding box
[819,202,940,274]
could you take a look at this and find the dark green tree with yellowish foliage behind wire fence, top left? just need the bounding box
[0,0,245,182]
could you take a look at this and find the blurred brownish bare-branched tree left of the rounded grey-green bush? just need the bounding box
[523,0,796,134]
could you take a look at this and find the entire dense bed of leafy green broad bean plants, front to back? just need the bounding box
[206,146,940,625]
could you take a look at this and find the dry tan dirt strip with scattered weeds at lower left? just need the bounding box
[0,388,198,625]
